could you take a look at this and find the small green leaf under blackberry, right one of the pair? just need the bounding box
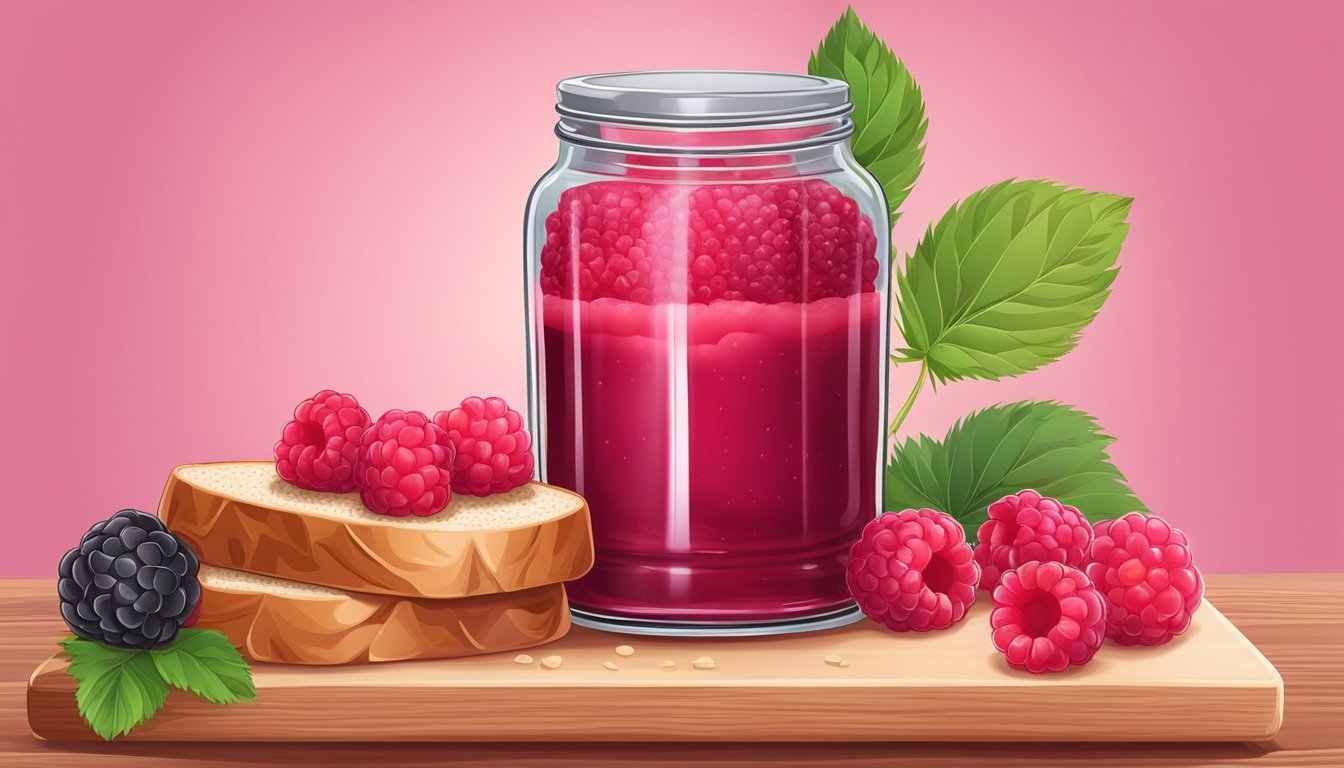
[149,629,257,703]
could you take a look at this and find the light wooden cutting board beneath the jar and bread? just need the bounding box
[28,603,1284,741]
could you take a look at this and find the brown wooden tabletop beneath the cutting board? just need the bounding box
[0,574,1344,767]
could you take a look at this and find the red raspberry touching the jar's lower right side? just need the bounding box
[845,510,980,632]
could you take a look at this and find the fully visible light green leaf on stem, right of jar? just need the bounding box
[896,180,1133,382]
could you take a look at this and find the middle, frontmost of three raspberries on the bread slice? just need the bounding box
[355,410,457,518]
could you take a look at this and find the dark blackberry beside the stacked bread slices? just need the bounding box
[56,510,200,648]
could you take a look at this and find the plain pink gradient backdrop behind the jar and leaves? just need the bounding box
[0,0,1344,576]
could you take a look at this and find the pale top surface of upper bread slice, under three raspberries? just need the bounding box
[173,461,583,531]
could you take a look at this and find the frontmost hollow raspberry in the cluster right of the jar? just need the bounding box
[989,561,1106,674]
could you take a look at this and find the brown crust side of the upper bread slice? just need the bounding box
[159,467,593,599]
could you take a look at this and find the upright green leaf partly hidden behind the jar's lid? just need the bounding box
[808,8,929,223]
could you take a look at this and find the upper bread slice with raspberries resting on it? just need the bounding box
[159,461,593,599]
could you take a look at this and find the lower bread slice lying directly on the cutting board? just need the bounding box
[196,564,570,664]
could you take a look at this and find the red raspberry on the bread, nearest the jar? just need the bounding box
[434,397,535,496]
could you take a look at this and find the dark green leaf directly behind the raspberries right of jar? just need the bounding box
[883,401,1148,542]
